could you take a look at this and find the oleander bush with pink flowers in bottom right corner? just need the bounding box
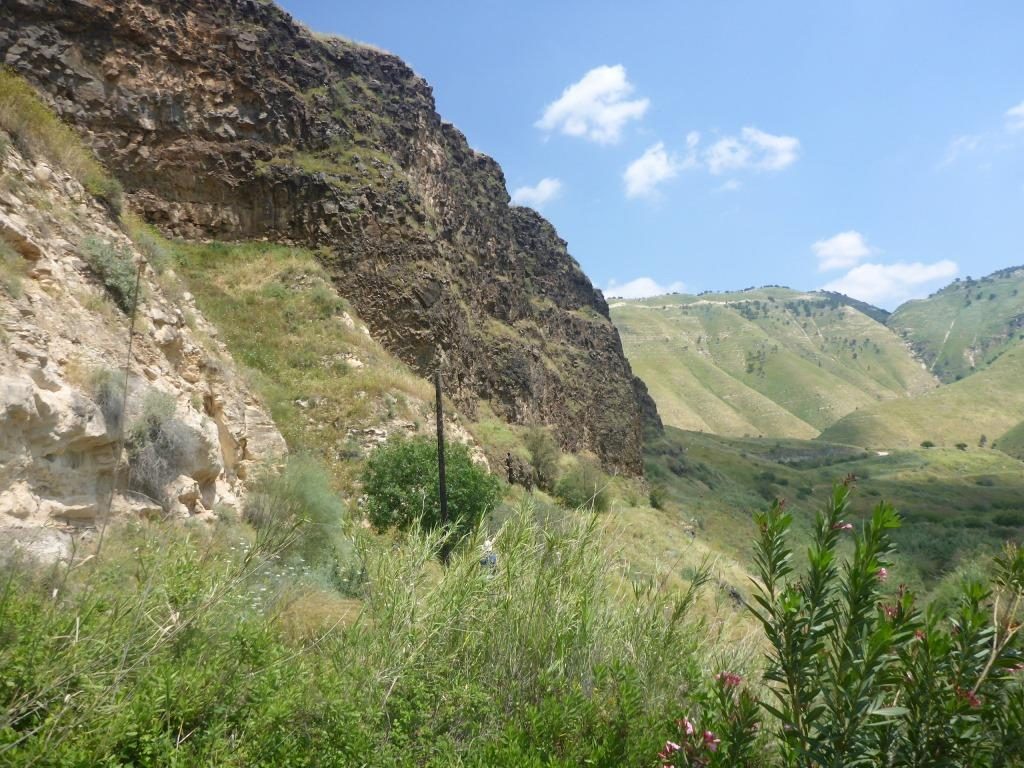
[659,482,1024,768]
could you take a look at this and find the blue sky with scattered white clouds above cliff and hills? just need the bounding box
[281,0,1024,308]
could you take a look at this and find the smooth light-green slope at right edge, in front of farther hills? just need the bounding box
[821,344,1024,449]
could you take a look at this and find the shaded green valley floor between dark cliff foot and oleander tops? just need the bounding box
[647,427,1024,593]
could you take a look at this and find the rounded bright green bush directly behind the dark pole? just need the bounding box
[362,438,501,539]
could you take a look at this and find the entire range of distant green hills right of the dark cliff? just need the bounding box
[610,266,1024,456]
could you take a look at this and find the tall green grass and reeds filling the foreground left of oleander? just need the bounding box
[0,505,720,767]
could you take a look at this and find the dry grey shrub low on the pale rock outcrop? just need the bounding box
[126,389,199,510]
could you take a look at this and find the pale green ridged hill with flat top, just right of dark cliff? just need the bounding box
[610,288,937,437]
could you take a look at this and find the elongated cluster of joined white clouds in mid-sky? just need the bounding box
[623,126,800,198]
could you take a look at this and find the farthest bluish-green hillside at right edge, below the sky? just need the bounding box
[888,267,1024,382]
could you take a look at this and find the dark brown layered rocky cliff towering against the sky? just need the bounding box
[0,0,657,474]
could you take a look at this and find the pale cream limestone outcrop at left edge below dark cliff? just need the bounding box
[0,137,287,558]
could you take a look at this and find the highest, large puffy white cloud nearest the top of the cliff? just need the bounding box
[535,65,650,144]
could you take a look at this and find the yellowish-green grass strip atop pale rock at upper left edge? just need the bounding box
[0,68,123,213]
